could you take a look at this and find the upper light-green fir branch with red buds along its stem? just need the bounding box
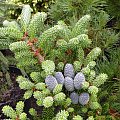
[1,5,94,74]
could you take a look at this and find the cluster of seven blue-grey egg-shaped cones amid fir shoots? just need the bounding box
[45,63,89,105]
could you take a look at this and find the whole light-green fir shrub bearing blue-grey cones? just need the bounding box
[0,5,116,120]
